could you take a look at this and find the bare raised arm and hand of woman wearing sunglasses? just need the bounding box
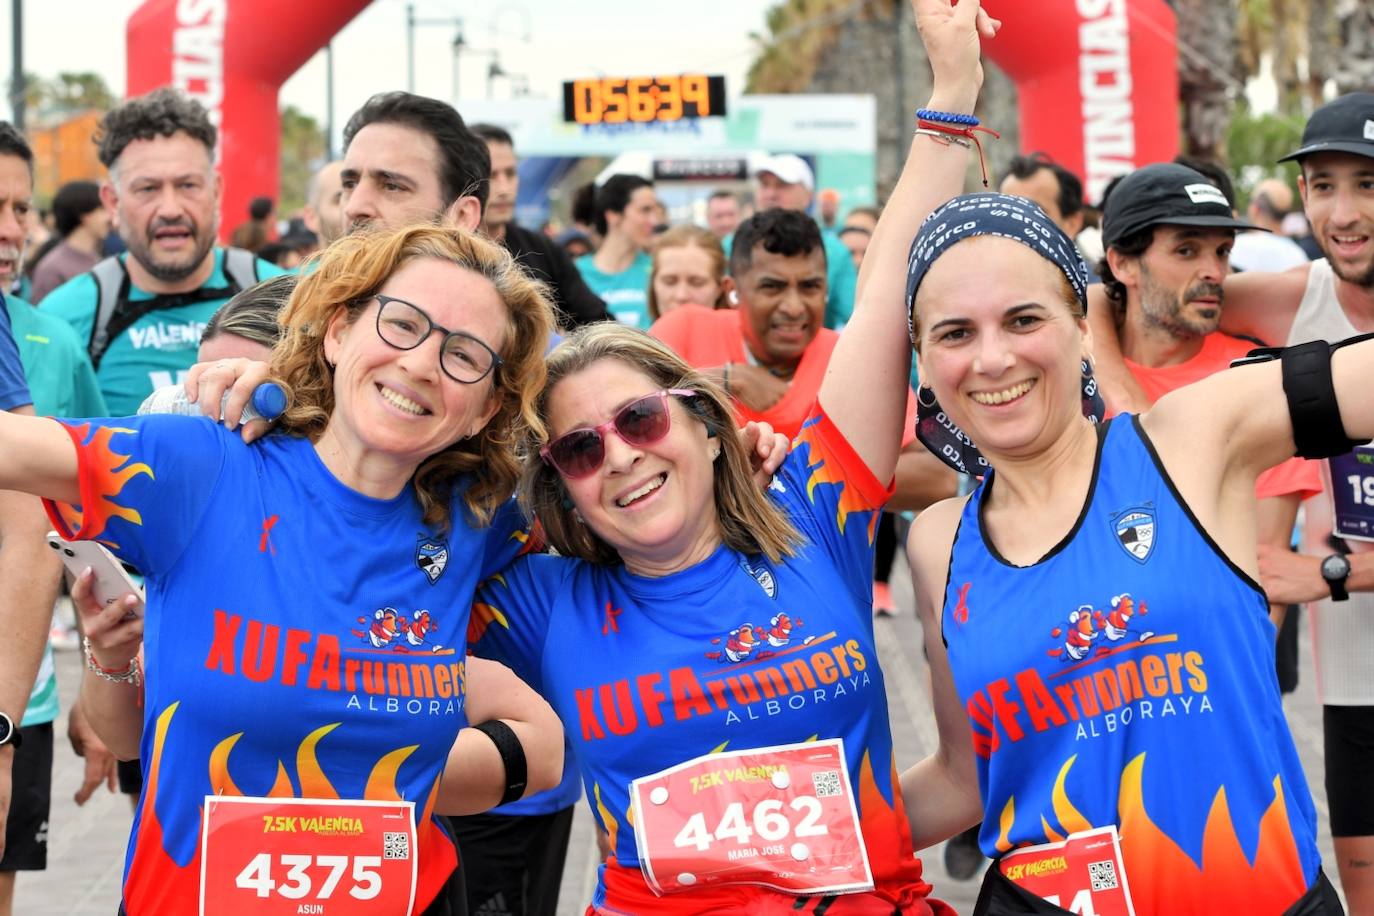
[820,0,998,481]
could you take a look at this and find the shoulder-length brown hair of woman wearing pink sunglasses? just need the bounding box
[521,321,801,566]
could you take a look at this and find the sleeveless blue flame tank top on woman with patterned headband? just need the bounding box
[941,416,1319,916]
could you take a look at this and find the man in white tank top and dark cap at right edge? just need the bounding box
[1090,92,1374,916]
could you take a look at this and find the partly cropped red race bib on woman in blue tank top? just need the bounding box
[998,824,1135,916]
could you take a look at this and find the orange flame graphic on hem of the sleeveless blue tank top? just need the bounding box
[996,753,1308,916]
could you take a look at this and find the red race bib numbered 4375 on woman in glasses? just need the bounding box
[201,795,416,916]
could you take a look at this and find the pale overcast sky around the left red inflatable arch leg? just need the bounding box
[0,0,769,144]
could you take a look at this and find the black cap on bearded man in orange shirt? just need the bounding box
[1102,162,1260,244]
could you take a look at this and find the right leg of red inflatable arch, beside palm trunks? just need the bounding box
[984,0,1179,202]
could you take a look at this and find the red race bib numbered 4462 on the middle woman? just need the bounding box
[629,739,872,894]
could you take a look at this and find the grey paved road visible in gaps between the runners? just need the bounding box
[15,563,1337,916]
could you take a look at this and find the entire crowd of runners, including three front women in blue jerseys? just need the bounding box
[0,0,1374,916]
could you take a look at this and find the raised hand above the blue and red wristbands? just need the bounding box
[911,0,1002,114]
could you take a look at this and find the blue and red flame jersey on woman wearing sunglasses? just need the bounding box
[470,415,943,915]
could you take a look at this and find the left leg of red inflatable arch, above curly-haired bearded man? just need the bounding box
[126,0,368,238]
